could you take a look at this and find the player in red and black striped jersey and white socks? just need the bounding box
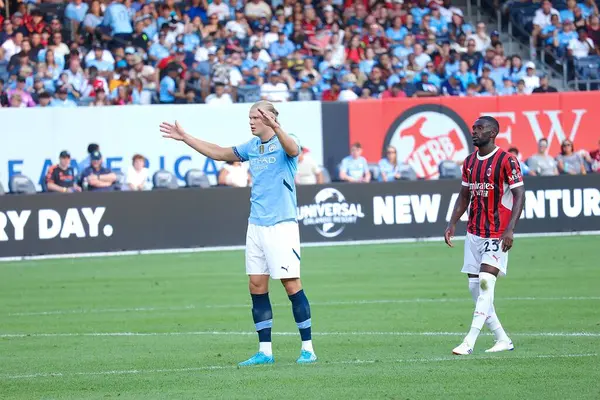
[444,116,525,355]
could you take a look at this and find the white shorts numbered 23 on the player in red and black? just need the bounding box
[461,232,508,275]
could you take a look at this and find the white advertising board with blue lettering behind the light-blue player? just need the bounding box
[0,102,323,191]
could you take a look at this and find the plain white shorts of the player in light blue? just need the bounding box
[246,221,300,279]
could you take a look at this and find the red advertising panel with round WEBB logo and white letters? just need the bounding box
[349,92,600,178]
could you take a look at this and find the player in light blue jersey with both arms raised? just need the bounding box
[160,101,317,366]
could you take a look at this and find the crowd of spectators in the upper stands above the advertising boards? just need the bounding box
[0,0,600,107]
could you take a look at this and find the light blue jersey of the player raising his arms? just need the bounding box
[233,135,299,226]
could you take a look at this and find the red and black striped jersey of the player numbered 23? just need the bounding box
[462,147,523,238]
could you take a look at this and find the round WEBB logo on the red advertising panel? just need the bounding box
[383,104,472,179]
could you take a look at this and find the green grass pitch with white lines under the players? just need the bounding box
[0,236,600,400]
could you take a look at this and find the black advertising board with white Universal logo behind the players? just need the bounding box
[0,175,600,258]
